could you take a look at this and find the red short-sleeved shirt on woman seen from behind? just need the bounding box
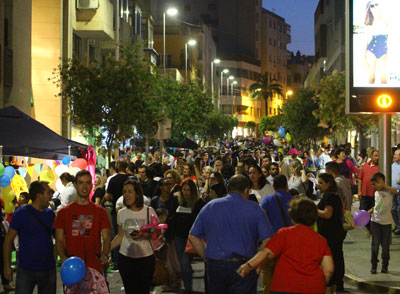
[265,225,332,294]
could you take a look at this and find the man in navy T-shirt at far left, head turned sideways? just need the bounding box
[4,181,57,294]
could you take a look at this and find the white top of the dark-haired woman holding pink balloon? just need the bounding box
[117,206,156,258]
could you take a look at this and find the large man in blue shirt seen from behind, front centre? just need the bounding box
[189,175,273,294]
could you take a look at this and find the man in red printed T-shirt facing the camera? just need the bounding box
[54,170,111,273]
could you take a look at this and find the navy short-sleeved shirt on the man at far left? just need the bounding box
[10,204,56,271]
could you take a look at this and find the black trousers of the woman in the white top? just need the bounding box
[118,254,155,294]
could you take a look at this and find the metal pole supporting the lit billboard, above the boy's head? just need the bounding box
[379,114,392,186]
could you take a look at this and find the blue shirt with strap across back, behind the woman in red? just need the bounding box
[261,190,293,232]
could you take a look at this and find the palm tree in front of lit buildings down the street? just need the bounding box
[247,72,282,115]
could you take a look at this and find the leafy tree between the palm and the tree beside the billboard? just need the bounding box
[282,89,328,142]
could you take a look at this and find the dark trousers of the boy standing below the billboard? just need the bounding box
[371,222,392,268]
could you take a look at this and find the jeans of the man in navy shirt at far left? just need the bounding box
[15,268,57,294]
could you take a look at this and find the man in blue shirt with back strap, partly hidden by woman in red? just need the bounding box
[261,175,293,294]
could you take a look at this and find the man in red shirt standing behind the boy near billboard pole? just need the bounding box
[358,149,379,231]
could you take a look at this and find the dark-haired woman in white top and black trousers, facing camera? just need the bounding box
[111,180,156,294]
